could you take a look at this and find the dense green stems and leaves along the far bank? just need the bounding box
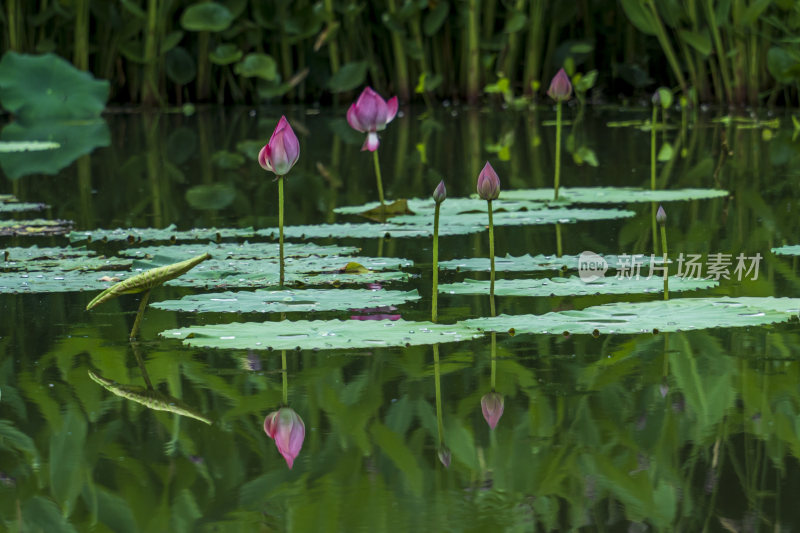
[0,0,800,105]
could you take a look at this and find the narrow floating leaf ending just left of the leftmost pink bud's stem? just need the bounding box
[69,224,255,243]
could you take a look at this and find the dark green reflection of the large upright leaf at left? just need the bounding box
[0,119,111,180]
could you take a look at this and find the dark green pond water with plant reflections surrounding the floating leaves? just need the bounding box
[0,108,800,532]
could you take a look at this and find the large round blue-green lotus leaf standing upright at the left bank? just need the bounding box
[0,52,110,120]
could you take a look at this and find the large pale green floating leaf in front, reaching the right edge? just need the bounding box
[459,296,800,335]
